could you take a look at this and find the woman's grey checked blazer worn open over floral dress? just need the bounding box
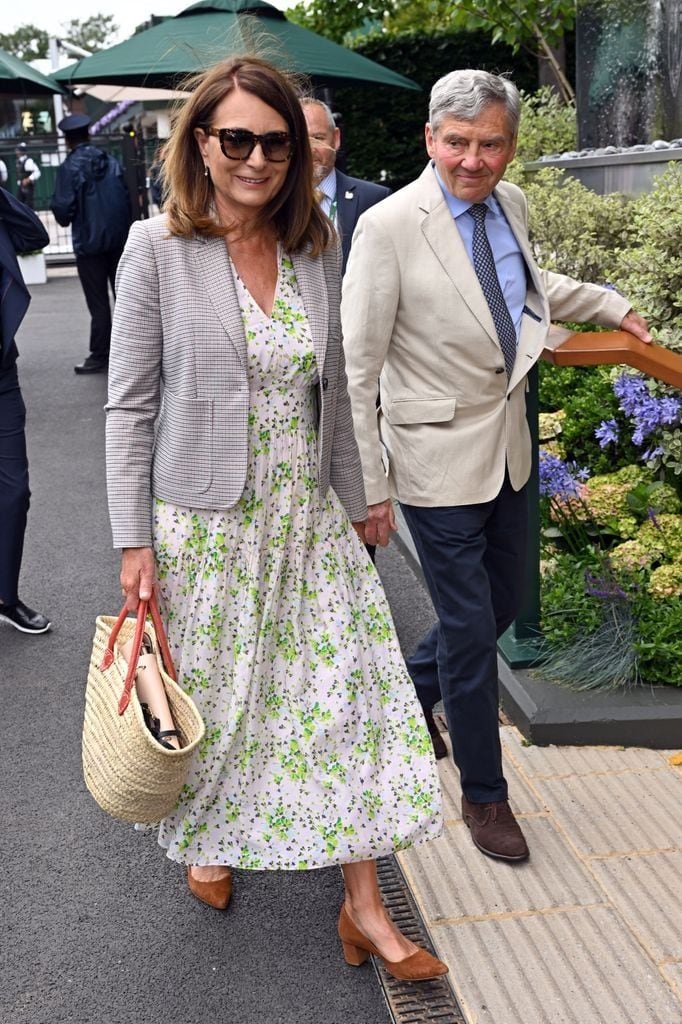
[105,215,367,548]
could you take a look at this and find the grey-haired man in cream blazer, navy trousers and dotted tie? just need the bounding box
[342,71,650,862]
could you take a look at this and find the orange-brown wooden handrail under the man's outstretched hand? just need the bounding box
[543,327,682,388]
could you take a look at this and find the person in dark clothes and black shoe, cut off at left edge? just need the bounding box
[0,188,50,634]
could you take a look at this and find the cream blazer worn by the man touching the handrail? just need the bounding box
[341,164,630,506]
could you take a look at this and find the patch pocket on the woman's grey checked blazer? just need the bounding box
[154,390,213,494]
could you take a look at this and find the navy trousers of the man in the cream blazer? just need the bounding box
[400,478,527,804]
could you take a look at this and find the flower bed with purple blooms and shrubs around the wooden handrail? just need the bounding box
[507,105,682,688]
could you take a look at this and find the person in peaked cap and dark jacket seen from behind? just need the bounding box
[50,114,130,374]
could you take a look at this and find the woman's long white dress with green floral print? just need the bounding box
[154,247,441,869]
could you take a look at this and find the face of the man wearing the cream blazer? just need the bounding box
[426,103,516,203]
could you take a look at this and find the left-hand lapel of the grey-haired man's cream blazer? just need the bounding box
[420,165,500,356]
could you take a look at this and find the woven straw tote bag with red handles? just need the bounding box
[83,594,205,824]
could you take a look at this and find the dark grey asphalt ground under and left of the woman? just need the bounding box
[0,276,432,1024]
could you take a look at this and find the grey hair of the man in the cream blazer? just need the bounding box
[429,69,521,138]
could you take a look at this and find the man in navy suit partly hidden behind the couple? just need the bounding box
[302,99,391,272]
